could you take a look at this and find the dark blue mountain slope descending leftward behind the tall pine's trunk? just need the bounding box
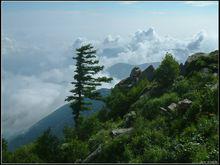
[8,88,110,151]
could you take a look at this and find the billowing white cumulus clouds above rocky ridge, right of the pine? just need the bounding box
[97,28,217,67]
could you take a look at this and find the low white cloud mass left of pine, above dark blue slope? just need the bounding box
[2,72,68,137]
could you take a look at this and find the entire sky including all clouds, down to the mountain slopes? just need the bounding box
[1,1,218,138]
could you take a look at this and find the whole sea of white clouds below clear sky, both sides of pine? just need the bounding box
[1,28,217,138]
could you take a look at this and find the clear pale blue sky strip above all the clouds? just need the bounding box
[3,1,218,38]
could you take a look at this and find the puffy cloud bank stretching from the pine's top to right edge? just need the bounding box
[74,28,217,67]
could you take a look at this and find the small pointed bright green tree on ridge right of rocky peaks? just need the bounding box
[155,53,180,87]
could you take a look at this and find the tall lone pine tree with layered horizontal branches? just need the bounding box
[65,44,112,128]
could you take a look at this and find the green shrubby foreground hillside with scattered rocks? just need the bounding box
[2,50,219,163]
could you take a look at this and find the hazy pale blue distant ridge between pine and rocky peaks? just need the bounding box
[106,62,160,80]
